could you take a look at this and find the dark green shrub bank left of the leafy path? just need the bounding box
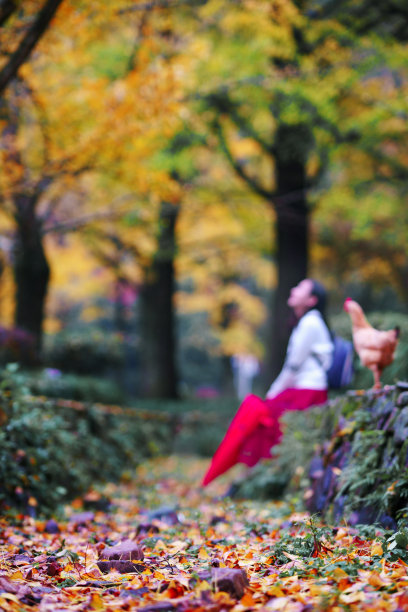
[0,366,175,513]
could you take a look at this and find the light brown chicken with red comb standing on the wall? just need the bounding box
[344,298,400,389]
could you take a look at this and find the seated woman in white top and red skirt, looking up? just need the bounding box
[202,278,333,486]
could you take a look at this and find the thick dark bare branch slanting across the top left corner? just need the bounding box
[0,0,63,95]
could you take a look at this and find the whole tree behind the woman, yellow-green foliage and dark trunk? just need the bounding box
[177,0,408,373]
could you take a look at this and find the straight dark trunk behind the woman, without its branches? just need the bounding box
[270,124,312,381]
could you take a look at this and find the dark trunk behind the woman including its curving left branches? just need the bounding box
[209,110,314,382]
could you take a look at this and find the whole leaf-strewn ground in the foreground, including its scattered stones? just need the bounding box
[0,457,408,612]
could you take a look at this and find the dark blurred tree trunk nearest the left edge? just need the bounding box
[13,195,50,358]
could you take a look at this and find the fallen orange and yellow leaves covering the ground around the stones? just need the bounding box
[0,456,408,612]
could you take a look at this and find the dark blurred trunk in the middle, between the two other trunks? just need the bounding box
[140,202,179,399]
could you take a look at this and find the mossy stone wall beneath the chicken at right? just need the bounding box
[305,382,408,528]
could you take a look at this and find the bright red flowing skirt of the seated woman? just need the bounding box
[202,389,327,486]
